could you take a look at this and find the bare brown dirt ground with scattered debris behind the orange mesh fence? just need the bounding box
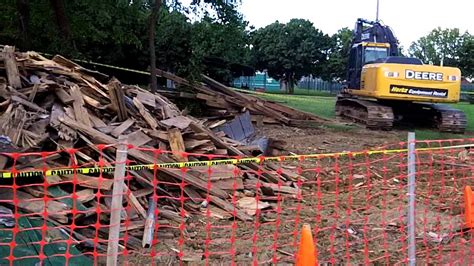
[122,125,474,265]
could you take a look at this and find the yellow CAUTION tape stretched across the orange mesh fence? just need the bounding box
[0,144,474,179]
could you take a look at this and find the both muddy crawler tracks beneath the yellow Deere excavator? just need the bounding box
[336,96,467,134]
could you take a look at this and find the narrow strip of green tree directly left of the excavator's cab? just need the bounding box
[321,28,352,81]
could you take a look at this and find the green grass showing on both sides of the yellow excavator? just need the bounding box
[254,93,474,140]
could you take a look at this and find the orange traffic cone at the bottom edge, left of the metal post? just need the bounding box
[295,224,318,266]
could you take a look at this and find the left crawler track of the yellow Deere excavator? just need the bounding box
[336,97,394,130]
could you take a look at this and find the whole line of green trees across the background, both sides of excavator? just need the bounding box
[0,0,474,93]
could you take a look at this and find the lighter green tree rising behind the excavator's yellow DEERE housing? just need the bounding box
[409,27,470,66]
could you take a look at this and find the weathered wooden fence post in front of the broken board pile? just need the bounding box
[107,136,128,266]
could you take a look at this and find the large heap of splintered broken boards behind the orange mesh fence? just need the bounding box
[0,46,299,249]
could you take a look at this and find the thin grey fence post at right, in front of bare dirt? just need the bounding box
[407,132,416,266]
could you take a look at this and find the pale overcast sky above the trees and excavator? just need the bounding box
[240,0,474,49]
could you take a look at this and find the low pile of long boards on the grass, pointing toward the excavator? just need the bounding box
[150,70,334,128]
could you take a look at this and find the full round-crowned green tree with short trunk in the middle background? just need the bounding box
[252,19,331,93]
